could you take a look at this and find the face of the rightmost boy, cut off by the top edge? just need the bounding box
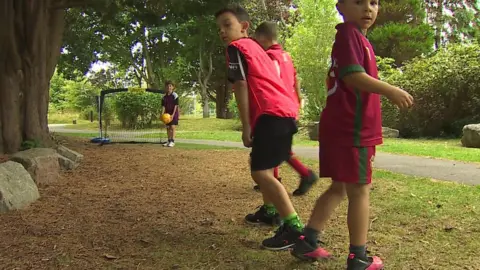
[337,0,379,30]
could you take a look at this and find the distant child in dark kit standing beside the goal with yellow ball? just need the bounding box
[162,81,179,147]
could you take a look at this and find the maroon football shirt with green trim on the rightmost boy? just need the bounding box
[319,23,382,147]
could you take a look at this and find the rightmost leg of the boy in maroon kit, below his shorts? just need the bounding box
[346,184,370,259]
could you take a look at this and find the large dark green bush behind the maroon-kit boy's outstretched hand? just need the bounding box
[383,44,480,137]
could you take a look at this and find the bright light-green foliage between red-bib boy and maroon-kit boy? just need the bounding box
[286,0,338,120]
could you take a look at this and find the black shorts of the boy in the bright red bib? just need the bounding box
[250,115,298,171]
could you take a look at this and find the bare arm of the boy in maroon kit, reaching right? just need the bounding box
[343,72,413,109]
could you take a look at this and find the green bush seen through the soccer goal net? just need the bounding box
[113,92,162,129]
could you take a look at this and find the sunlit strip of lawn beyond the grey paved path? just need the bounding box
[49,117,480,163]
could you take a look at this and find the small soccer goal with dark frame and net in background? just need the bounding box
[91,88,166,144]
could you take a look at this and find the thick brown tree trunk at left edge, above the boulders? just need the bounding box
[0,0,65,153]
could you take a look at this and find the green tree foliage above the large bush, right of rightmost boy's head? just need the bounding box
[368,0,434,65]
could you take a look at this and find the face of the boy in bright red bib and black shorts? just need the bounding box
[217,12,249,45]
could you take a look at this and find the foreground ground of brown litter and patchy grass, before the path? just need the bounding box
[0,142,480,270]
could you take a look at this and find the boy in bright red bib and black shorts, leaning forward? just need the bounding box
[215,6,303,250]
